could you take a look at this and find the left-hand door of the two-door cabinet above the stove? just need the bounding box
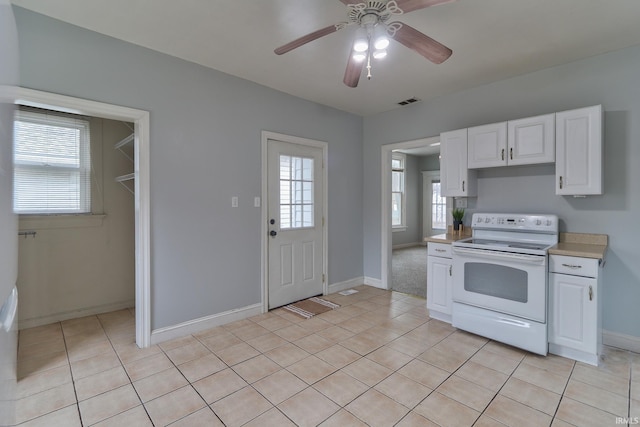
[467,122,507,169]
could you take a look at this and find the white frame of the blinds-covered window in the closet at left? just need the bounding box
[13,107,92,218]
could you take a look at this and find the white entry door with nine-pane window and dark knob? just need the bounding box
[267,139,324,308]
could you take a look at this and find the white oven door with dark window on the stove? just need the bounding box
[452,246,547,323]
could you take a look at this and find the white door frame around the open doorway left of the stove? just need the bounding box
[379,136,440,289]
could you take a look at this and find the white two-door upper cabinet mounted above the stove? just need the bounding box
[468,114,556,169]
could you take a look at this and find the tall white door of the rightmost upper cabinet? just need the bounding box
[556,105,602,195]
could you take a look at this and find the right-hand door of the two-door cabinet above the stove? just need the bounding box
[507,114,556,166]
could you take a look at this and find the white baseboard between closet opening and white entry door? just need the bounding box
[151,303,262,345]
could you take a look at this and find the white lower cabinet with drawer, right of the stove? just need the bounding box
[548,255,602,365]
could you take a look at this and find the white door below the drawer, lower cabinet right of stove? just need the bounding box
[549,273,599,354]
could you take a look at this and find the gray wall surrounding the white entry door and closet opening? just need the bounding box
[15,8,363,329]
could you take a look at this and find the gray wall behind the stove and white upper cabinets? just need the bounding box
[363,46,640,337]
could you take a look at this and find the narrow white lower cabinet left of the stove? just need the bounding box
[427,243,453,323]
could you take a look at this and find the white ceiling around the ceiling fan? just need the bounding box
[12,0,640,116]
